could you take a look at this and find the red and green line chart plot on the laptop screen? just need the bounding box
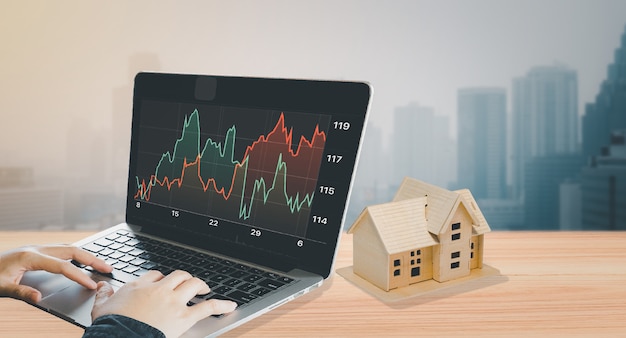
[134,104,330,235]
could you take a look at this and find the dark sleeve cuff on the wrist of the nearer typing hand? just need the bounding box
[83,315,165,338]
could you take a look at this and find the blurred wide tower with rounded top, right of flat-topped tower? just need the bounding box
[511,64,584,229]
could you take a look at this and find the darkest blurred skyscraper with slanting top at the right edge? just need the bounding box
[580,24,626,230]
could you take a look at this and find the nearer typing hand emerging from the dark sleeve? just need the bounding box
[91,270,237,337]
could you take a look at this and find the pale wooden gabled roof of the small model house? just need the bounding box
[348,177,491,254]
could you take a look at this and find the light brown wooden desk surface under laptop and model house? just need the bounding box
[0,232,626,337]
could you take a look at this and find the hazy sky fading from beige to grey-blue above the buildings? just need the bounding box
[0,0,626,177]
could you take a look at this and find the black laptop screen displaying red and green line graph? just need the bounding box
[127,73,370,277]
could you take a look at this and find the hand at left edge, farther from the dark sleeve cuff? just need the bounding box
[0,245,113,303]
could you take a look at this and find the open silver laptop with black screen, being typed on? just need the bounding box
[23,72,371,337]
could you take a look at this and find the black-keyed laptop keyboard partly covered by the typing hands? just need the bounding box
[77,230,294,307]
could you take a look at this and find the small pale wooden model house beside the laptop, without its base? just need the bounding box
[348,178,491,291]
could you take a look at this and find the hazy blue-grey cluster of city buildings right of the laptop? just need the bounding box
[348,27,626,230]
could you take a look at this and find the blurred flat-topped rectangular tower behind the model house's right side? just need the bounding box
[457,88,507,199]
